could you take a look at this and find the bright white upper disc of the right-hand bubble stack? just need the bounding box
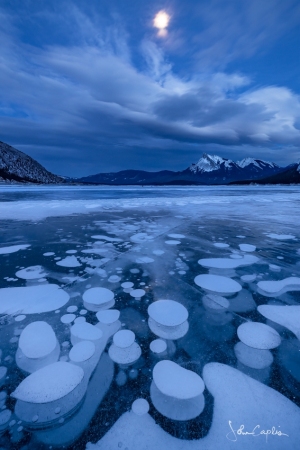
[237,322,281,350]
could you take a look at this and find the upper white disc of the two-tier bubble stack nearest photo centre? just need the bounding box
[148,300,189,327]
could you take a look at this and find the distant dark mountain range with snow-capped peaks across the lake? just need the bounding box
[77,153,284,185]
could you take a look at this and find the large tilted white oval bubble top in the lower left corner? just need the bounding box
[11,361,84,403]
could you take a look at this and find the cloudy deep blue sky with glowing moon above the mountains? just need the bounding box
[0,0,300,177]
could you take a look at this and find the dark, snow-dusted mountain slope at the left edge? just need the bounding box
[0,141,63,184]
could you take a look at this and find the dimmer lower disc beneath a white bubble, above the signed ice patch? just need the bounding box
[234,342,274,370]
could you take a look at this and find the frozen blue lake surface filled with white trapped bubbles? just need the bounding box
[0,186,300,450]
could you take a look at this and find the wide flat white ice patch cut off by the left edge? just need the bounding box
[0,284,69,314]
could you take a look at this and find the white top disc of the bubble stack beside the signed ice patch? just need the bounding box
[153,360,205,400]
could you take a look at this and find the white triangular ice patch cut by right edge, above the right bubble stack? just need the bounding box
[257,305,300,339]
